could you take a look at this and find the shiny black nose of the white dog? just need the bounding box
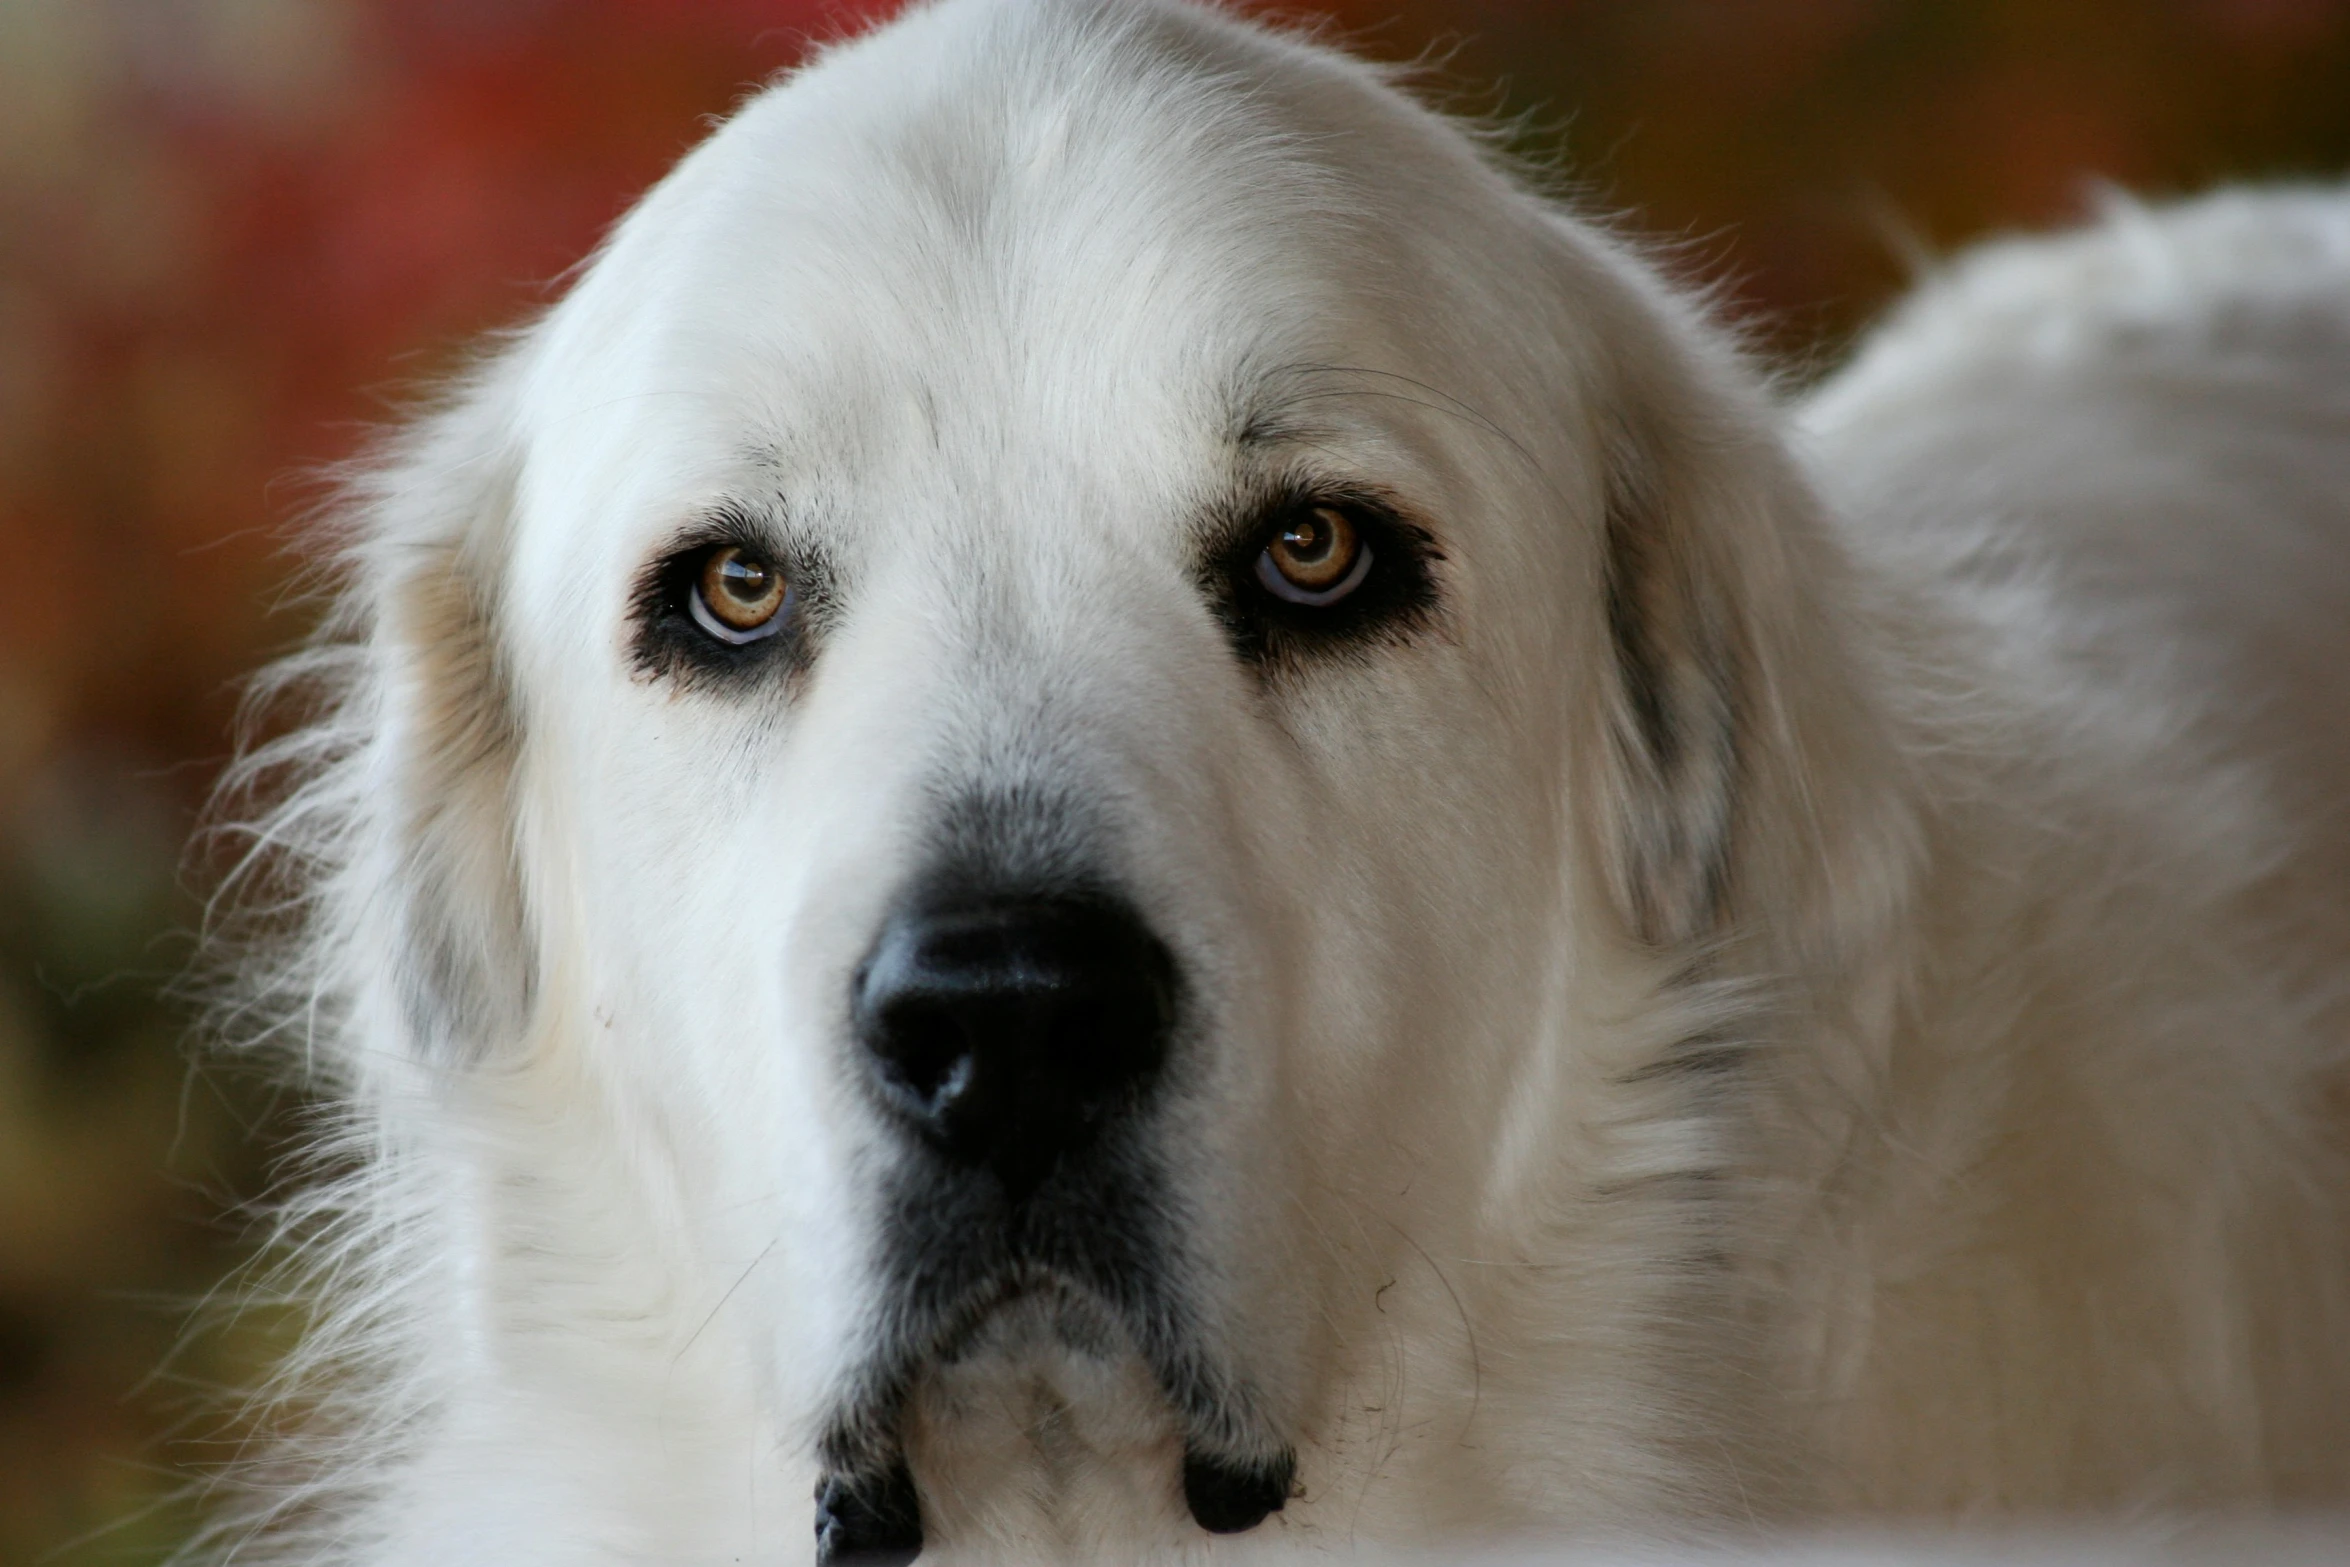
[853,897,1175,1196]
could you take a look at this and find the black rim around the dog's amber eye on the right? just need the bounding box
[1203,484,1443,670]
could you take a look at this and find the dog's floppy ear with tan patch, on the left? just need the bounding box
[348,378,536,1060]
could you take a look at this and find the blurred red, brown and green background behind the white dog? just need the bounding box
[0,0,2350,1567]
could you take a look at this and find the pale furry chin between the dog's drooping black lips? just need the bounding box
[902,1287,1196,1555]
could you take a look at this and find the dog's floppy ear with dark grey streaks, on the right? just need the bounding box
[1584,263,1906,949]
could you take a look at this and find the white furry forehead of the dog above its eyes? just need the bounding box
[519,5,1466,563]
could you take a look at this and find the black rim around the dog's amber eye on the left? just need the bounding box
[630,510,830,686]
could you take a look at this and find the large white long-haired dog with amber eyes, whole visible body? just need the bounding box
[206,0,2350,1567]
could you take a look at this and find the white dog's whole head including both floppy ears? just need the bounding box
[340,5,1861,1551]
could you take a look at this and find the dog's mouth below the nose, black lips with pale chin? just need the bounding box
[818,1141,1297,1562]
